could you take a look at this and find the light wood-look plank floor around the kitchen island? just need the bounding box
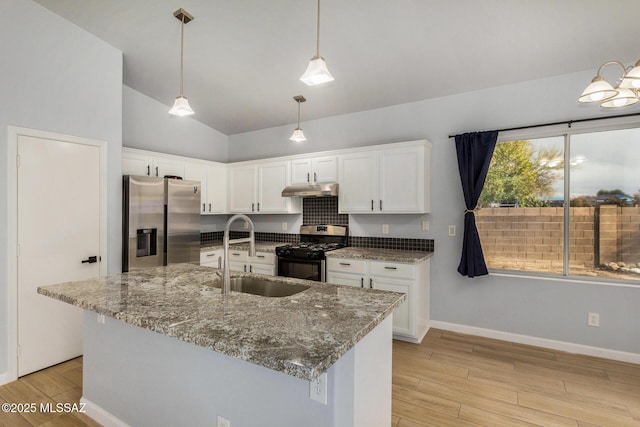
[0,329,640,427]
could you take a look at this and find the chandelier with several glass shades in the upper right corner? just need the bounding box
[578,61,640,108]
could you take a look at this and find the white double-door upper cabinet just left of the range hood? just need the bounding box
[229,161,301,214]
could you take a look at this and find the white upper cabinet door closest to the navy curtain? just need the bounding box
[378,147,425,213]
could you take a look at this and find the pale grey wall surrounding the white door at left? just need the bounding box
[0,0,122,376]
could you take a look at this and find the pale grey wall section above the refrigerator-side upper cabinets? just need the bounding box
[122,86,227,162]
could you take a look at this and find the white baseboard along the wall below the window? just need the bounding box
[431,320,640,364]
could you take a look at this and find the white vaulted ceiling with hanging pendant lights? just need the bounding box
[36,0,640,135]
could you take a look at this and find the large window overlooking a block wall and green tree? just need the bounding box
[476,129,640,281]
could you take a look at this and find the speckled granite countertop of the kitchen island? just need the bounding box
[38,264,406,380]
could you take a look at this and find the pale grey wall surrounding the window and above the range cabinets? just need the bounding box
[229,72,640,354]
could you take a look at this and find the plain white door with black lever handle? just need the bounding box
[17,135,101,376]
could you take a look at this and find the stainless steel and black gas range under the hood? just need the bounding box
[276,225,348,282]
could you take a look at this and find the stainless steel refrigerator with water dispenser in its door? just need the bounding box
[122,175,200,272]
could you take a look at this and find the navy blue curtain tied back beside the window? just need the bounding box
[455,131,498,277]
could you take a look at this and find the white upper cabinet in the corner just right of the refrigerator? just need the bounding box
[184,161,227,215]
